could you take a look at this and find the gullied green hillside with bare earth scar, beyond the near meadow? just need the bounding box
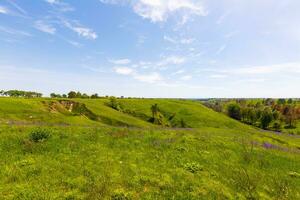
[0,98,248,128]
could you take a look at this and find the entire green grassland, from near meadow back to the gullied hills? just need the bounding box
[0,98,300,200]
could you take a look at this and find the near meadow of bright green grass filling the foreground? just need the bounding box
[0,127,300,199]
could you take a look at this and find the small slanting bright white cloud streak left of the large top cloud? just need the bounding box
[62,20,98,40]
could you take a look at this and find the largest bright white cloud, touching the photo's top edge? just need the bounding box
[100,0,207,24]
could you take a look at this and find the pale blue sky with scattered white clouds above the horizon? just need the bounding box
[0,0,300,98]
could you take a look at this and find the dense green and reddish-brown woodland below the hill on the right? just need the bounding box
[204,99,300,131]
